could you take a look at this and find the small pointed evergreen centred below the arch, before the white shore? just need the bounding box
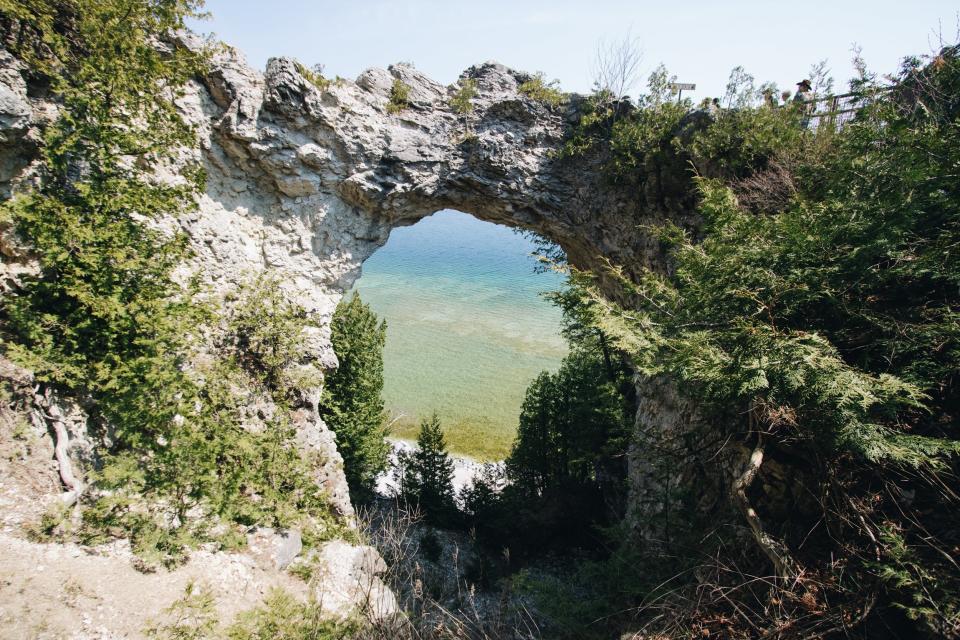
[403,413,455,521]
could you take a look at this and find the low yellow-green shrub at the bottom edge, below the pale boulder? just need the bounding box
[225,589,360,640]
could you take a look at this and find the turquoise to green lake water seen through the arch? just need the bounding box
[354,211,566,459]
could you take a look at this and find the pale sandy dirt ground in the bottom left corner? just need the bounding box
[0,534,305,640]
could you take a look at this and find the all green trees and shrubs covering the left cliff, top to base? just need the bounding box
[0,0,344,562]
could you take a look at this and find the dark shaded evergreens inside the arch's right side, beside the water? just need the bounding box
[459,290,632,565]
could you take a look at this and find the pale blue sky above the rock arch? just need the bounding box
[196,0,960,100]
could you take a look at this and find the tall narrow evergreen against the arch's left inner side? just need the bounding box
[320,294,388,497]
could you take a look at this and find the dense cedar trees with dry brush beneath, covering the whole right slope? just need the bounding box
[532,47,960,637]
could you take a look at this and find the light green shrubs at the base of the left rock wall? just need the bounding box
[81,278,339,565]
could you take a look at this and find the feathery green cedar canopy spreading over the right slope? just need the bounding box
[579,48,960,633]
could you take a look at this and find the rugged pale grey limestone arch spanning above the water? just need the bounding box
[0,34,720,560]
